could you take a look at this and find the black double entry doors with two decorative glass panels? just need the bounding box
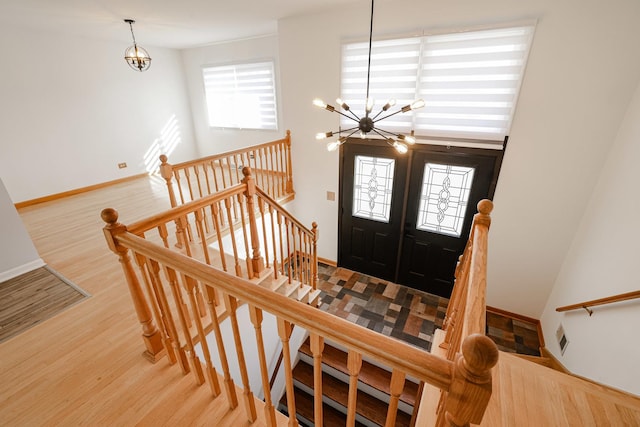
[338,140,502,298]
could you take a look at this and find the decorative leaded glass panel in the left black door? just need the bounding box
[352,155,396,223]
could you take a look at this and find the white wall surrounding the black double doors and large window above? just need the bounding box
[278,0,640,318]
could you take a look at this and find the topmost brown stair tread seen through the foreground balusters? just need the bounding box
[300,338,419,406]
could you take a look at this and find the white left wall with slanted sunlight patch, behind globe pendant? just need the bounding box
[0,26,196,202]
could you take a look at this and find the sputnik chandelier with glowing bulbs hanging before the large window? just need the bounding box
[313,0,425,154]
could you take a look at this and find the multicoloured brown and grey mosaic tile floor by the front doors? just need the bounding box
[318,264,540,356]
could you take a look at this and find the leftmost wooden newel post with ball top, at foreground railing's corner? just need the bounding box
[100,208,165,363]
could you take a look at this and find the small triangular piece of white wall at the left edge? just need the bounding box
[0,179,44,282]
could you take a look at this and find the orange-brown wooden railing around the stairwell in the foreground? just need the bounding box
[102,195,498,426]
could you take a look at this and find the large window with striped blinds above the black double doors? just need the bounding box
[341,26,534,143]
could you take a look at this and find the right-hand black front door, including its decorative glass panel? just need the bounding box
[397,151,496,298]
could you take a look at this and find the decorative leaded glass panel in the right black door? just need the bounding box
[416,163,475,237]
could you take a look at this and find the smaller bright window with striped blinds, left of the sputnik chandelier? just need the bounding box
[202,61,278,130]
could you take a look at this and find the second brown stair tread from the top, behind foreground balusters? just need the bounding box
[293,360,411,426]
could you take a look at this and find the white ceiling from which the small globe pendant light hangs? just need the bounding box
[0,0,361,49]
